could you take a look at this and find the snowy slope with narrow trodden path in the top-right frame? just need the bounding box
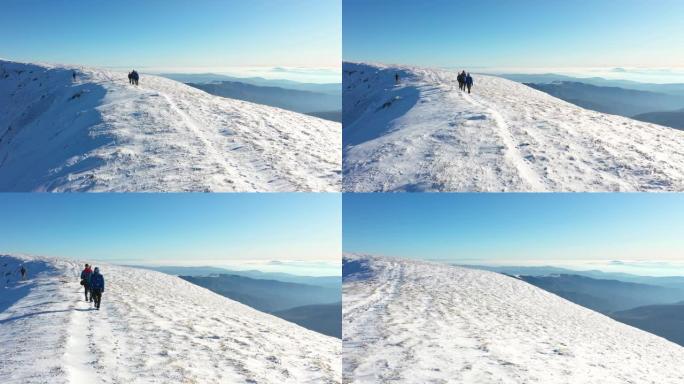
[342,63,684,191]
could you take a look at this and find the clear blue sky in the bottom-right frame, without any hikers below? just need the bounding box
[343,193,684,274]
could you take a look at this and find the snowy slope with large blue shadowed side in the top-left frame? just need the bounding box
[0,60,341,191]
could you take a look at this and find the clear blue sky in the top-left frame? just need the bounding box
[0,0,342,68]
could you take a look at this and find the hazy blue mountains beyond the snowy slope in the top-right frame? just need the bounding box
[500,73,684,129]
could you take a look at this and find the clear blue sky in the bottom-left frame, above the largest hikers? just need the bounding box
[0,193,342,272]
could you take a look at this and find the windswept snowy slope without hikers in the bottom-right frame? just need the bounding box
[342,255,684,384]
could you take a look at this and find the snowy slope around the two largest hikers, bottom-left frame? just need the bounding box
[0,256,341,384]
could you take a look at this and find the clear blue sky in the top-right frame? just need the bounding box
[343,0,684,68]
